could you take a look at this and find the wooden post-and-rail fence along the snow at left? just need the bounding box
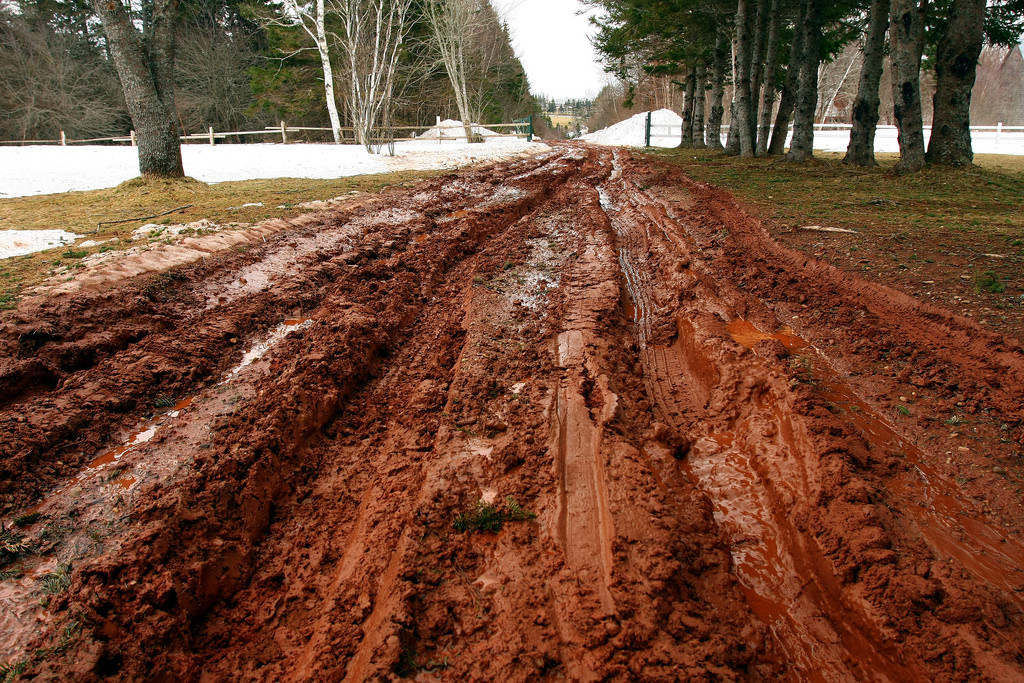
[0,117,534,146]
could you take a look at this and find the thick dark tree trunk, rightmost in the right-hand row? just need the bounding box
[927,0,985,166]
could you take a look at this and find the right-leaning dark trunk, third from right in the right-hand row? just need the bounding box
[843,0,889,166]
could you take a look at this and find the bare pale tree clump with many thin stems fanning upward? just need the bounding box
[338,0,412,153]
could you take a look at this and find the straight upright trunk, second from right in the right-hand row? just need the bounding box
[889,0,928,173]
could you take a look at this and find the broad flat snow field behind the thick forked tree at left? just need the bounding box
[0,134,548,197]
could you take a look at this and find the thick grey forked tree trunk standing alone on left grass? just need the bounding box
[92,0,184,178]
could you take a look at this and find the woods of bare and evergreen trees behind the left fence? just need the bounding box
[0,0,536,142]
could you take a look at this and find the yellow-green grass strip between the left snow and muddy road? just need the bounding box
[0,171,443,310]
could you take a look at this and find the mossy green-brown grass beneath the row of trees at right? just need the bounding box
[650,150,1024,241]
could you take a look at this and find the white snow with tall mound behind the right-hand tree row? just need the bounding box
[583,110,1024,155]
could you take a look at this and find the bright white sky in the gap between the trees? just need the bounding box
[492,0,608,99]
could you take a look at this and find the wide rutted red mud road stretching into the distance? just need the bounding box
[0,146,1024,681]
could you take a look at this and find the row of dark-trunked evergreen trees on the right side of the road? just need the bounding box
[591,0,1024,171]
